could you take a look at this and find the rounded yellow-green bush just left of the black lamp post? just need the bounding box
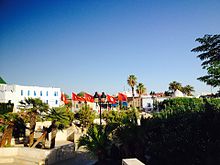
[76,105,96,127]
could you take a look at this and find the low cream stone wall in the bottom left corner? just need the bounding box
[0,142,74,165]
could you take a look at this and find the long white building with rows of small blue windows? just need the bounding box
[0,84,61,112]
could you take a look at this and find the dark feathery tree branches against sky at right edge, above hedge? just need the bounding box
[191,34,220,87]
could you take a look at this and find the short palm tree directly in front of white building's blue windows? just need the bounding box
[20,98,49,147]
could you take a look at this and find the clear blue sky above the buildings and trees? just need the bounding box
[0,0,220,95]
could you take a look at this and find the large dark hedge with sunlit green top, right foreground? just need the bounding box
[114,98,220,165]
